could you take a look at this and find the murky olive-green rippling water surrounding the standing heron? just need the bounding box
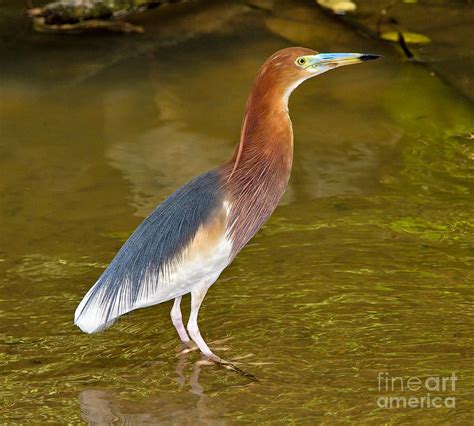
[0,0,474,424]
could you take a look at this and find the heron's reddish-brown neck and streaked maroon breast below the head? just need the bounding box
[221,80,293,255]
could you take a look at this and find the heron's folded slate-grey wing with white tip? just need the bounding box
[74,171,223,333]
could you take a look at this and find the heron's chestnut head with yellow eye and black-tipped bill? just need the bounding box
[258,47,380,101]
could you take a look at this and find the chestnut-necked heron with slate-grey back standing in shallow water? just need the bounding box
[74,47,380,363]
